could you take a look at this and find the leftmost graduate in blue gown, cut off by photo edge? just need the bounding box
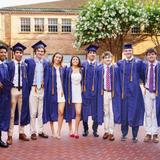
[0,46,13,148]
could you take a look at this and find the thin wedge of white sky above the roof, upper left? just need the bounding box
[0,0,60,8]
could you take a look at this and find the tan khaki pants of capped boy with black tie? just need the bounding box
[9,88,24,136]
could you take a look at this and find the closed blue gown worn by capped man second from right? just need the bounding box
[117,58,144,127]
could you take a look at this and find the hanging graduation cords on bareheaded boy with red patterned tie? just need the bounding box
[101,65,115,98]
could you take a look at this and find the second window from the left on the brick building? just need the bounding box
[34,18,44,32]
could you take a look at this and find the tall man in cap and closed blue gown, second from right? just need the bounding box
[117,44,144,143]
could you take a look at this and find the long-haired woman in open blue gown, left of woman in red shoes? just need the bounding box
[43,52,65,138]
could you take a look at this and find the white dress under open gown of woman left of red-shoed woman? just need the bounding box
[55,67,65,103]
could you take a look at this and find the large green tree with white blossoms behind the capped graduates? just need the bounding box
[75,0,147,59]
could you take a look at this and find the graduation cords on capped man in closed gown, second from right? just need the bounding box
[122,58,135,99]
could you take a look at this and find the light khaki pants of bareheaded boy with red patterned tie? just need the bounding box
[103,91,114,134]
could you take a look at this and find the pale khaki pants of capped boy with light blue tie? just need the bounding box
[29,86,44,134]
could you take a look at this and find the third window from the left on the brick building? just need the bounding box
[48,18,58,32]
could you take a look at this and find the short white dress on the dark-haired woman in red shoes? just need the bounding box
[71,72,82,103]
